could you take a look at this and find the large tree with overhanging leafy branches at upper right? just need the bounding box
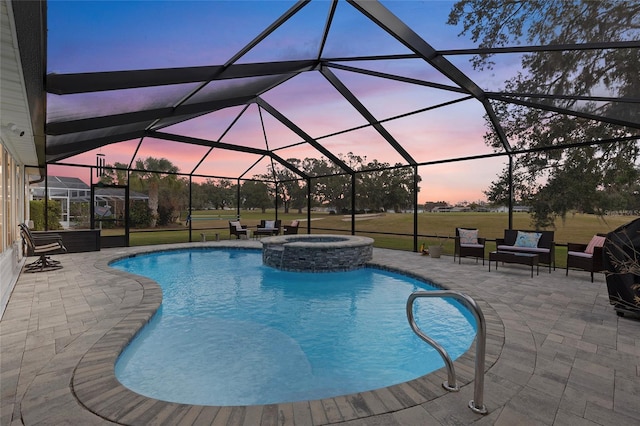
[448,0,640,227]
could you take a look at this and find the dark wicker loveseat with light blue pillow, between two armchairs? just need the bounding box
[496,229,556,272]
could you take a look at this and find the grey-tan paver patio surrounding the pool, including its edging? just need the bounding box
[0,241,640,426]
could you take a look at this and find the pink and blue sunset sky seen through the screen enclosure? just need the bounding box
[48,0,520,203]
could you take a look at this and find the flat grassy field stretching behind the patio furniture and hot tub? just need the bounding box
[131,210,637,266]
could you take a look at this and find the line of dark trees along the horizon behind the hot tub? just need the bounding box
[101,153,420,227]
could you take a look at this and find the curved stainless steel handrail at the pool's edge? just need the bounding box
[407,290,488,414]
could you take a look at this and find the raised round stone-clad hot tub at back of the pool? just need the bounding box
[260,234,373,272]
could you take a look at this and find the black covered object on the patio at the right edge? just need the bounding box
[603,219,640,315]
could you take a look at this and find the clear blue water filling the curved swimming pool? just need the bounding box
[111,249,475,406]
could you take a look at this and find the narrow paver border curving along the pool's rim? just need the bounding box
[71,244,505,424]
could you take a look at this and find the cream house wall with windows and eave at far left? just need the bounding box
[0,0,36,318]
